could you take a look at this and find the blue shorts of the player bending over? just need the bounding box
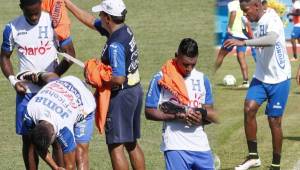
[74,112,95,143]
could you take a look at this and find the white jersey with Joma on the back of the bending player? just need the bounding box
[27,76,96,137]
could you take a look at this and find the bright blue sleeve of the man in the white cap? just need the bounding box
[108,43,126,76]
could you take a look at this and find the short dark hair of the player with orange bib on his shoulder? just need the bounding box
[178,38,198,58]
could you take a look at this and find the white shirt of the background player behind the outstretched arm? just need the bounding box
[227,0,248,39]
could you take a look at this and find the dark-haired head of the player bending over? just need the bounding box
[31,121,54,154]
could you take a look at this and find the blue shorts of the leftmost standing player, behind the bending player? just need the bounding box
[16,93,36,135]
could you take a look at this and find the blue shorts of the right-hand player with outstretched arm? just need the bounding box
[246,78,291,117]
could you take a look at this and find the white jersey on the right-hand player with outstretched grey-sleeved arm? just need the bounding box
[254,8,291,84]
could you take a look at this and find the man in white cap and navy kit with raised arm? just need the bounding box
[65,0,145,169]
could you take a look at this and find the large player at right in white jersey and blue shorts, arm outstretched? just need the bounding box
[224,0,291,170]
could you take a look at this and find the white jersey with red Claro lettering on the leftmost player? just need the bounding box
[1,12,58,93]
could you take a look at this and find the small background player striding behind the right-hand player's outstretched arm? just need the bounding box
[215,0,251,88]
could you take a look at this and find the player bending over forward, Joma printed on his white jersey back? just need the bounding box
[23,73,96,169]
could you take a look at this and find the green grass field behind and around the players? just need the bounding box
[0,0,300,170]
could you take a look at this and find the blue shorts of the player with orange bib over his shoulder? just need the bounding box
[164,150,214,170]
